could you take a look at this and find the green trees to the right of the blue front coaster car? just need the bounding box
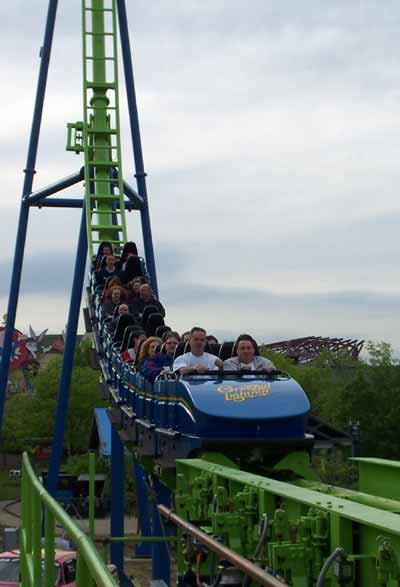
[263,342,400,459]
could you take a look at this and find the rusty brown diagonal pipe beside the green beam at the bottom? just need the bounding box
[158,505,282,587]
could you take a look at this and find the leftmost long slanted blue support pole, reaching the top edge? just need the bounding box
[0,0,58,432]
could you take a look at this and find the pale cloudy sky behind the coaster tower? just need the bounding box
[0,0,400,352]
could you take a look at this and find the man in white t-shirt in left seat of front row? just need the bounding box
[173,326,223,375]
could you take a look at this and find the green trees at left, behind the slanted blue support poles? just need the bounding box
[1,341,106,454]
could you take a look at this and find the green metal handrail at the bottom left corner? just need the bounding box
[20,453,117,587]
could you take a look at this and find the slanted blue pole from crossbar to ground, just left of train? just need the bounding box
[47,208,87,495]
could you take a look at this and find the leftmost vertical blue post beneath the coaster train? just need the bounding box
[110,426,125,577]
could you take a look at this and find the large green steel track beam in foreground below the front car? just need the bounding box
[175,459,400,587]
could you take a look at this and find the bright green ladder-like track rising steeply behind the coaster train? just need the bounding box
[67,0,127,256]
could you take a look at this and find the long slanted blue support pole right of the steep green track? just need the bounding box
[117,0,158,297]
